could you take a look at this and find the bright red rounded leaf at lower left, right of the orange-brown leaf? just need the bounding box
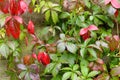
[38,52,50,65]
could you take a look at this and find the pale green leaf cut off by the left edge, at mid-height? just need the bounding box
[0,43,9,58]
